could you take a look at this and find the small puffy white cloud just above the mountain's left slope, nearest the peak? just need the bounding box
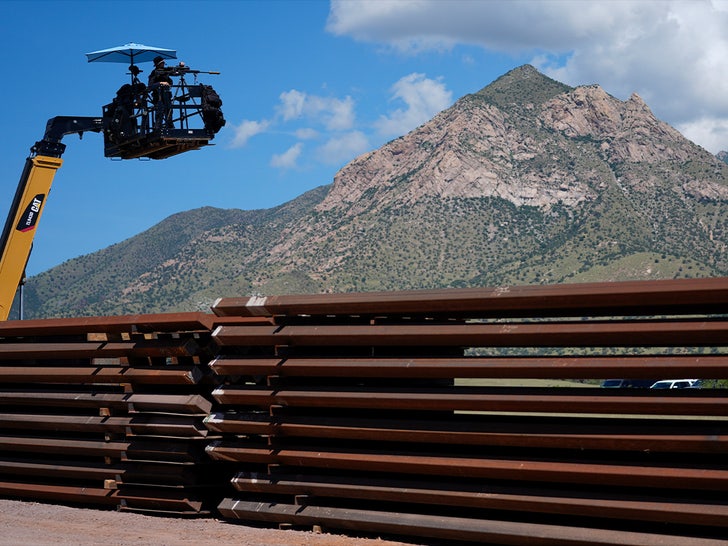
[375,73,452,136]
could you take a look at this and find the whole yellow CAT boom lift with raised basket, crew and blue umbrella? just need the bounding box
[0,44,225,321]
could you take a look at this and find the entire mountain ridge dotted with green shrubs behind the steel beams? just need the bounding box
[25,66,728,317]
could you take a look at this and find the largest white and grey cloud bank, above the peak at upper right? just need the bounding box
[327,0,728,152]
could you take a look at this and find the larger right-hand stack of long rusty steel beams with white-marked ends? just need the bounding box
[206,279,728,545]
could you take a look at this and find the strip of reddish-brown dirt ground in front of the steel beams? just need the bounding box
[0,499,420,546]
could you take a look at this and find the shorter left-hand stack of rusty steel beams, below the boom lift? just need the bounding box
[0,314,225,514]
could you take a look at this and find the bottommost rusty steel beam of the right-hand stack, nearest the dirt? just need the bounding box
[218,499,725,546]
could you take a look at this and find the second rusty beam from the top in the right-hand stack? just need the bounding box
[213,320,728,347]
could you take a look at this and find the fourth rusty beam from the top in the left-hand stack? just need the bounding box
[0,391,212,415]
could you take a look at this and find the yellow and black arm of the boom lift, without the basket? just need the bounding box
[0,116,103,321]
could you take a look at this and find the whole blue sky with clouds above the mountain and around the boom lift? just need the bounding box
[0,0,728,275]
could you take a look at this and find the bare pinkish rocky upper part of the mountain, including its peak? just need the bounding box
[319,65,697,215]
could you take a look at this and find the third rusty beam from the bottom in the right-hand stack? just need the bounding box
[206,441,728,491]
